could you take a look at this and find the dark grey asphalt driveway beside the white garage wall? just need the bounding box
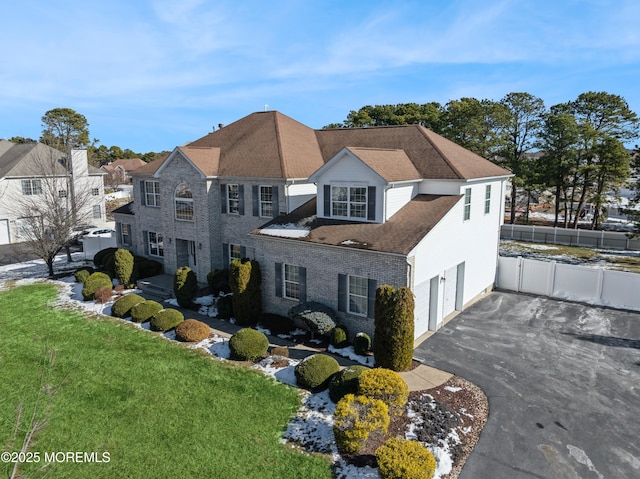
[415,292,640,479]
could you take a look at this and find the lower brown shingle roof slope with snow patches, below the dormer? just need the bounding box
[251,195,462,254]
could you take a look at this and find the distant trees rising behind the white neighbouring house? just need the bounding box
[9,108,166,167]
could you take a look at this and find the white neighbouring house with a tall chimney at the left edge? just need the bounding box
[0,140,105,244]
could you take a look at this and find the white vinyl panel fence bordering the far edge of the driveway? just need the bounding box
[496,256,640,311]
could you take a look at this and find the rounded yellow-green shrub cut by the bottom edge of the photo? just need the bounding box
[376,438,436,479]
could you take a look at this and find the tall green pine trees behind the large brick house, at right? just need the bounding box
[324,92,640,229]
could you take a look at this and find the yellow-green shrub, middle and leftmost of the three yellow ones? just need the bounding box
[333,394,390,454]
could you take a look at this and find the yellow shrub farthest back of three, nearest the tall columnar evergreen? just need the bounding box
[358,368,409,413]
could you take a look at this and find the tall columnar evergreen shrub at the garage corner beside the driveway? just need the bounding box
[373,285,414,371]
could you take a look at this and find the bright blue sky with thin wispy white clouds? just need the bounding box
[0,0,640,153]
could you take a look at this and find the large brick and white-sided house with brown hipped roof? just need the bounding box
[115,111,511,337]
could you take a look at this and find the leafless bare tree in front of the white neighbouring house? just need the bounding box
[11,144,91,276]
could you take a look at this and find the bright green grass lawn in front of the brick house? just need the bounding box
[0,284,331,479]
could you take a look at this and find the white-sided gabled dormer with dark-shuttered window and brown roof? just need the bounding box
[309,147,422,223]
